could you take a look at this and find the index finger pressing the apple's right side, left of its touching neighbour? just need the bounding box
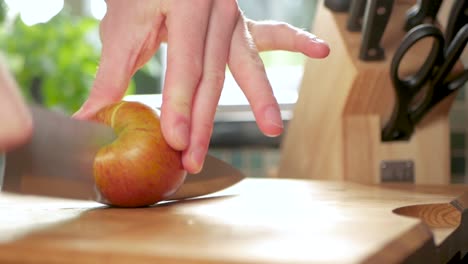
[161,0,212,150]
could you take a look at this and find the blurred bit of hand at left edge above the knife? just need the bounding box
[0,58,33,154]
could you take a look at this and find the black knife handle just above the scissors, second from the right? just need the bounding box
[404,0,442,31]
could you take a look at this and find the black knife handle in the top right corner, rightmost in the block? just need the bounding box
[445,0,468,45]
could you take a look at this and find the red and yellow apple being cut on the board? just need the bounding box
[93,101,187,207]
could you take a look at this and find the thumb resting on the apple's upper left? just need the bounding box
[73,42,135,119]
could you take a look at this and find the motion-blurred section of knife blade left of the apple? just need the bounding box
[2,105,115,199]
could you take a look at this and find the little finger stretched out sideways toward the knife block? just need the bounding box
[247,20,330,58]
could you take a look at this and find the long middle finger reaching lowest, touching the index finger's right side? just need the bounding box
[182,0,240,173]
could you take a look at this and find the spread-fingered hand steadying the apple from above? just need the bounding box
[75,0,329,173]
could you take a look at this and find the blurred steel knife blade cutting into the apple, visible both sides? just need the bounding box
[0,106,245,202]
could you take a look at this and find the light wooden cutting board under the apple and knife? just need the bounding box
[0,179,468,263]
